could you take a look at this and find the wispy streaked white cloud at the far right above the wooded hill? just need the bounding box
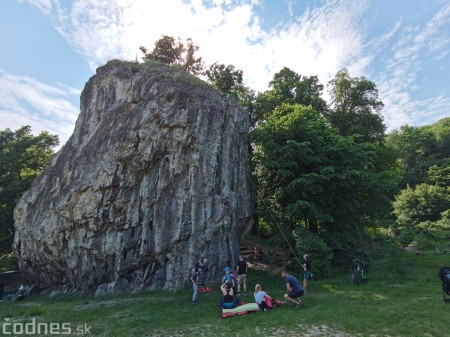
[377,4,450,130]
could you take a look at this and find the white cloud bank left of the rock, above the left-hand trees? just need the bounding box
[0,70,80,144]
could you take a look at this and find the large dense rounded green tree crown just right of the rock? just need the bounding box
[251,104,395,232]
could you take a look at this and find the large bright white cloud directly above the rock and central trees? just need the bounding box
[28,0,370,90]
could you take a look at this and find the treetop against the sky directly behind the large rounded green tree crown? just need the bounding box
[255,67,327,120]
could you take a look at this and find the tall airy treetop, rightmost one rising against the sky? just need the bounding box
[326,69,386,144]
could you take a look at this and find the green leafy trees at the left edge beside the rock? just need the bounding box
[0,126,59,253]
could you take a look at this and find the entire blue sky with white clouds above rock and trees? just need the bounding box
[0,0,450,144]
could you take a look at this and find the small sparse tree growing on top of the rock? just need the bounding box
[139,35,203,75]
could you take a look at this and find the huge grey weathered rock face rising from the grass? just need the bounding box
[14,61,254,293]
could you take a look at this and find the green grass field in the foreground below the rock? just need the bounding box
[0,252,450,337]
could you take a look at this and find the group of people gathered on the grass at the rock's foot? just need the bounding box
[191,254,312,310]
